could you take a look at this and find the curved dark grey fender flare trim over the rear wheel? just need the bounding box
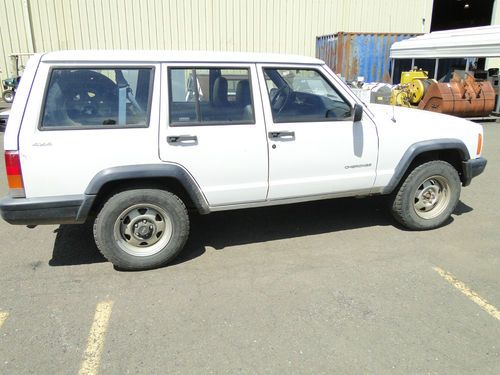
[85,163,210,214]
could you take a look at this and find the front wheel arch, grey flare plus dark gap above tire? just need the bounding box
[382,138,470,194]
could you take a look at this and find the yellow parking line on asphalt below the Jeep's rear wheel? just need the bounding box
[78,301,113,375]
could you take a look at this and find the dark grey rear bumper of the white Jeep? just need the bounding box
[0,195,95,225]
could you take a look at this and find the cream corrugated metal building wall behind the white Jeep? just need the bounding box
[0,0,433,82]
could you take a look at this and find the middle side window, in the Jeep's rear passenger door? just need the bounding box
[169,68,255,126]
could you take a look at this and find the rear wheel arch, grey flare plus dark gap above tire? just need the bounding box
[85,163,210,214]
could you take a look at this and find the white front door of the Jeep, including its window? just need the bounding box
[258,65,378,200]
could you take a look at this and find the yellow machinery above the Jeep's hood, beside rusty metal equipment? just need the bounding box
[390,69,436,107]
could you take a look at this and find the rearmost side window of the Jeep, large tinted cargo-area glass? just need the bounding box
[41,68,153,129]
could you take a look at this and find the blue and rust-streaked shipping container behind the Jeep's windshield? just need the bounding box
[316,32,420,83]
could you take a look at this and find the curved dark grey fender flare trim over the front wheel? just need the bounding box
[382,138,470,194]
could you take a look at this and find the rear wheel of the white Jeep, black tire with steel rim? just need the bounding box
[94,189,189,270]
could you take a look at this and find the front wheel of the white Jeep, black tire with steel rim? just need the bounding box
[391,160,461,230]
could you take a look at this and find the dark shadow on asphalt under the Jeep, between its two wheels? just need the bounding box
[186,197,393,250]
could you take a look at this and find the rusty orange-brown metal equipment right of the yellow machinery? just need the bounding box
[418,75,495,117]
